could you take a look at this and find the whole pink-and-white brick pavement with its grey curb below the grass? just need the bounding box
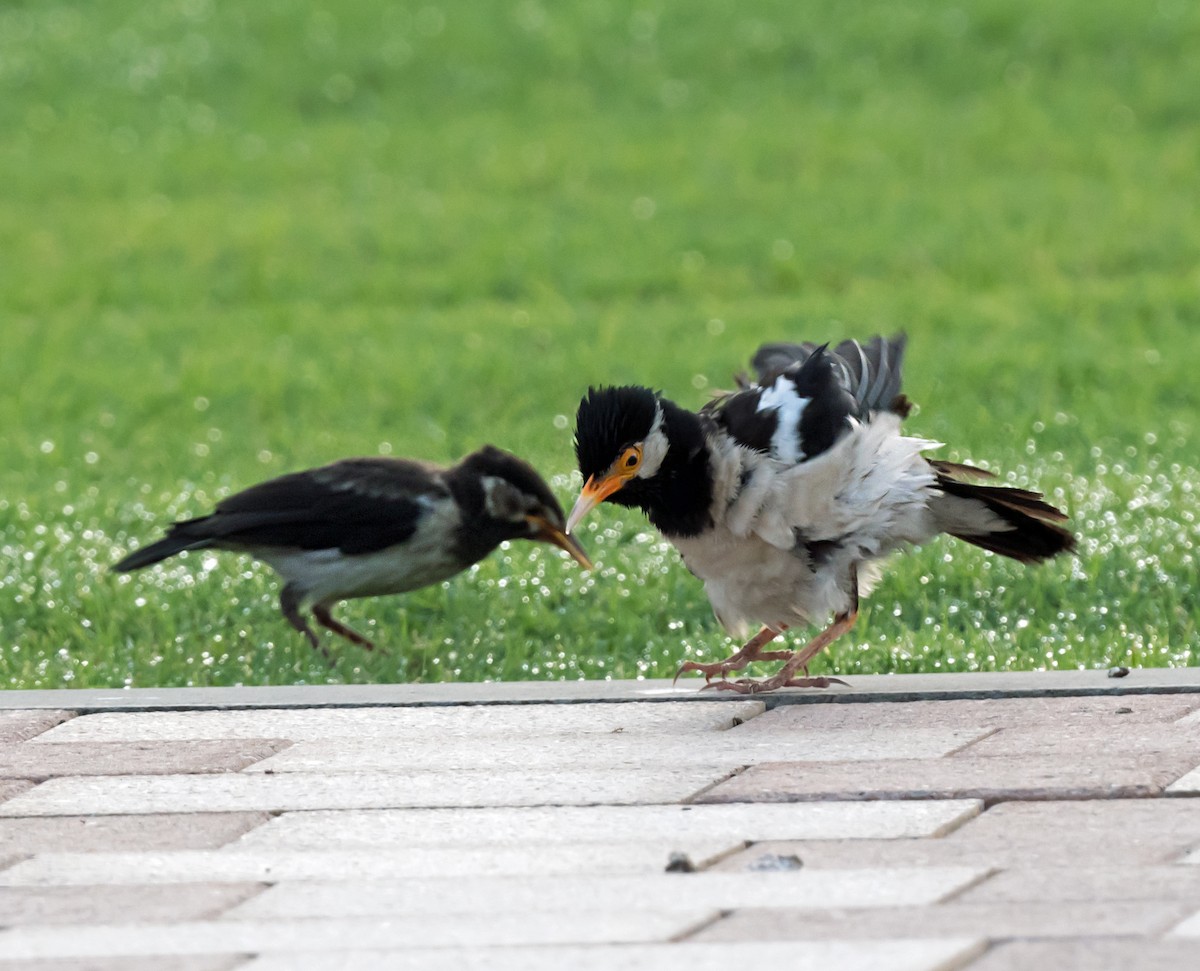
[0,672,1200,971]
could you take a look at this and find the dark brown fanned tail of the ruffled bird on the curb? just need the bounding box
[930,462,1075,563]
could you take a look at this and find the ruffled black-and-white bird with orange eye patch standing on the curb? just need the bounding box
[566,335,1074,694]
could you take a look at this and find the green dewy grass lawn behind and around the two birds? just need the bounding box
[0,0,1200,688]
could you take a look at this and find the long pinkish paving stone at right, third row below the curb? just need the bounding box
[696,751,1195,803]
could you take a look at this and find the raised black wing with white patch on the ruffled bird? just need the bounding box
[703,335,908,463]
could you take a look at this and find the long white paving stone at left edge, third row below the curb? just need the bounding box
[0,766,736,816]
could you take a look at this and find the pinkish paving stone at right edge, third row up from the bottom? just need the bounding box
[954,861,1200,907]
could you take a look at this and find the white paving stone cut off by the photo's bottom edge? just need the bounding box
[245,939,984,971]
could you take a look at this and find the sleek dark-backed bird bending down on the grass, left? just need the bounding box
[113,445,592,651]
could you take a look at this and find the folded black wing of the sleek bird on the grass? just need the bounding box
[175,458,450,553]
